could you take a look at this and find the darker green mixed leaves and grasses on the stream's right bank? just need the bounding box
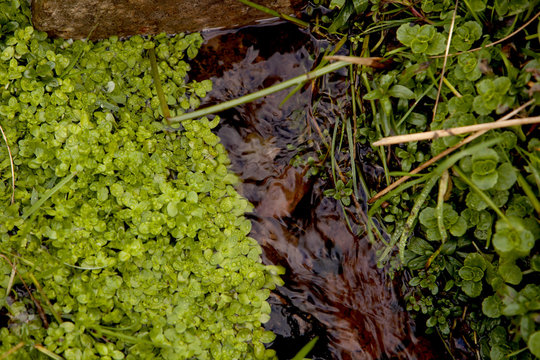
[304,0,540,359]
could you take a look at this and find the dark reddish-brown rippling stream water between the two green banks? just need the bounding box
[192,24,443,359]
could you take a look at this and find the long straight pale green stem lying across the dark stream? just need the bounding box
[169,61,349,122]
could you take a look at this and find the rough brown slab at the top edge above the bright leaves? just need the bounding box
[32,0,303,39]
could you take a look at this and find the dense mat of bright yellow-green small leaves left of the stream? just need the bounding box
[0,0,281,360]
